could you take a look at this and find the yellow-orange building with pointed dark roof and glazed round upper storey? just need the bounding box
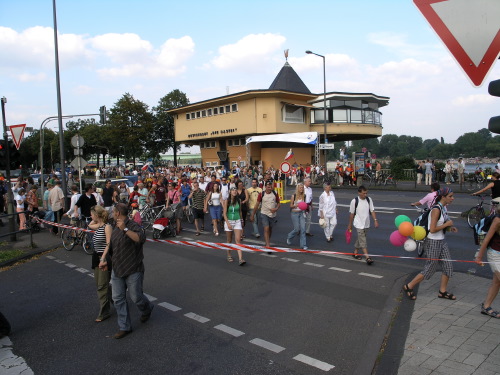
[168,62,389,168]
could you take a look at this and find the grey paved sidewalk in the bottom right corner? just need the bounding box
[398,272,500,375]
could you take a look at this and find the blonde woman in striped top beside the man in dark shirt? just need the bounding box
[89,206,113,323]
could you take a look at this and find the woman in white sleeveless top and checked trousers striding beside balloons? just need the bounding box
[403,187,458,300]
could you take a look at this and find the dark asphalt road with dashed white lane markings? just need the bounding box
[0,189,489,374]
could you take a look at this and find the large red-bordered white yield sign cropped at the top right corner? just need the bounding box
[413,0,500,86]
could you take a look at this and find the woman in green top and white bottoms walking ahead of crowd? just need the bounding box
[222,187,246,266]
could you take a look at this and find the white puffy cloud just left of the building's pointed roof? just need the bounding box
[211,33,286,70]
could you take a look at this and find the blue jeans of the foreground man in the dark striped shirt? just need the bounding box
[111,271,153,331]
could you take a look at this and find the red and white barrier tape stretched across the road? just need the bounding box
[33,218,489,264]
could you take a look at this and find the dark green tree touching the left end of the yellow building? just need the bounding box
[147,89,189,157]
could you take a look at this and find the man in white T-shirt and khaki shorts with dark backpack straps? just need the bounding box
[347,185,378,266]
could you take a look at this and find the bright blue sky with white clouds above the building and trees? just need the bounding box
[0,0,500,153]
